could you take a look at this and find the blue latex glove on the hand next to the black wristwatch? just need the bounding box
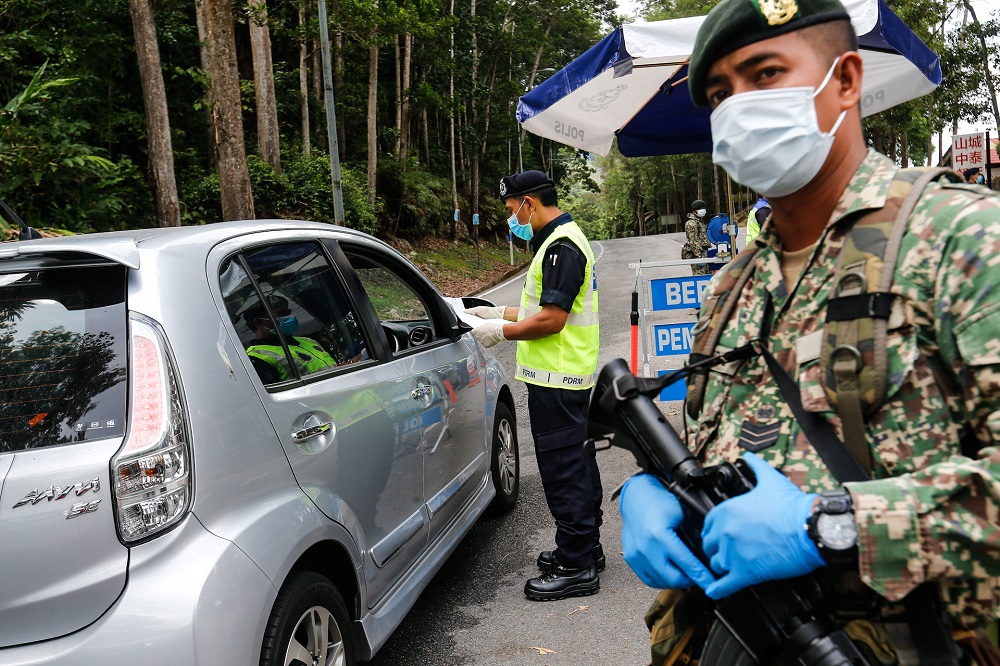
[701,453,826,599]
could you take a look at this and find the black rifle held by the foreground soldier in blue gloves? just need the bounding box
[587,358,870,666]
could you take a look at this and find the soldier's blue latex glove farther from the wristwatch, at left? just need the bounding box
[618,474,715,590]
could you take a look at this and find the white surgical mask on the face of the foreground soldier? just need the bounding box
[711,56,847,198]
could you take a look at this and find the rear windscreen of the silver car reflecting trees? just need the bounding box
[0,266,128,453]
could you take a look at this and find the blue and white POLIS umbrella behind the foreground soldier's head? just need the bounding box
[517,0,941,157]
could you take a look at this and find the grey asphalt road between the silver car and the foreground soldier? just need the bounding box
[371,234,704,666]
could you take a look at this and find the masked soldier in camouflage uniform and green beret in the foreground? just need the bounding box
[621,0,1000,666]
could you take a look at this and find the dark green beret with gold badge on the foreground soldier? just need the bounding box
[688,0,851,107]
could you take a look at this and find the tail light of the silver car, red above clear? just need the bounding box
[111,314,193,542]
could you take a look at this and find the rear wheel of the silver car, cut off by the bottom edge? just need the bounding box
[260,572,357,666]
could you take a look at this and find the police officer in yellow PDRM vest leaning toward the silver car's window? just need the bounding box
[466,171,605,601]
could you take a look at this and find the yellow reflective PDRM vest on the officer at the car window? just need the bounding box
[516,222,601,390]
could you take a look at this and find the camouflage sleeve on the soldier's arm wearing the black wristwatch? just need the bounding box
[846,195,1000,606]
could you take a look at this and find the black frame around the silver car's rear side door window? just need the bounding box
[220,236,388,394]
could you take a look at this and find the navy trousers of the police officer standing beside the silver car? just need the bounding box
[528,384,604,569]
